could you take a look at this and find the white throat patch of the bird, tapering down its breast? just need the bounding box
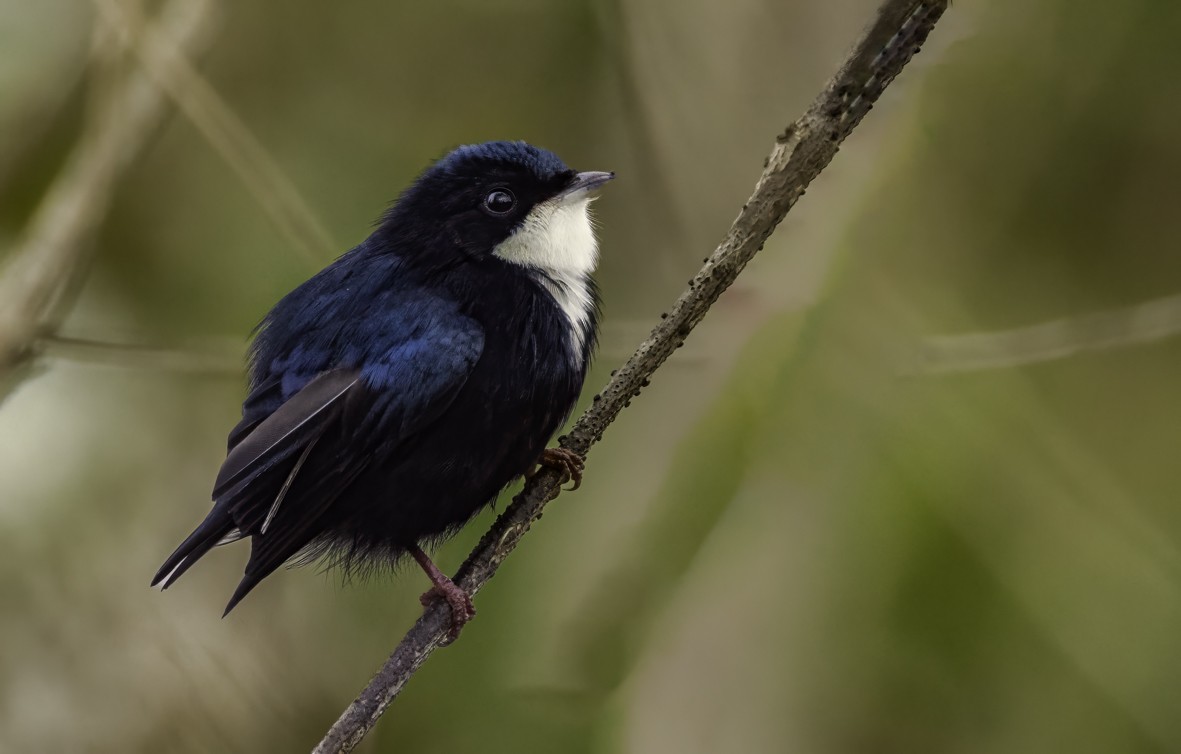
[492,194,599,363]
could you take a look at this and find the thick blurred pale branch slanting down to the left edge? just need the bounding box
[0,0,214,399]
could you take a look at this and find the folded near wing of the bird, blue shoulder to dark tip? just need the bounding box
[218,312,483,611]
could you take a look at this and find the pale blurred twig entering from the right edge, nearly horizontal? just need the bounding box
[902,294,1181,375]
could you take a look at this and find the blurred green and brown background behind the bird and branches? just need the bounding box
[0,0,1181,754]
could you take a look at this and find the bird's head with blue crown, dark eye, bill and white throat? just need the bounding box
[381,142,614,275]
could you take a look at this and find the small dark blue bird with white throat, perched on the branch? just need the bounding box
[151,141,615,637]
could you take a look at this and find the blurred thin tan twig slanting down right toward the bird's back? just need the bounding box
[93,0,337,267]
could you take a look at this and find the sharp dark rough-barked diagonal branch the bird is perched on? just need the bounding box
[314,0,947,754]
